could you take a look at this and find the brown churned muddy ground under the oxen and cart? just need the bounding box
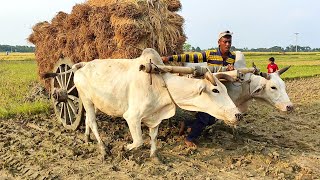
[0,77,320,179]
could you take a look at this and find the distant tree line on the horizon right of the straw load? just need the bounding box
[183,43,320,52]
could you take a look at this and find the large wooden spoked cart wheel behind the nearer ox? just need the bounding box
[51,58,84,130]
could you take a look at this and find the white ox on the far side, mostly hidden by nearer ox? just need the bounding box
[184,51,293,112]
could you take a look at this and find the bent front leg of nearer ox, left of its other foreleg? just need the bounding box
[127,119,143,150]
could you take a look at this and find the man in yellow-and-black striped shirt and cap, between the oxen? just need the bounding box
[162,31,236,147]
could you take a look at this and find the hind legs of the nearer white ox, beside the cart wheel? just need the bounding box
[83,102,106,157]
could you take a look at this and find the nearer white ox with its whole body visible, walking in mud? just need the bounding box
[55,48,241,156]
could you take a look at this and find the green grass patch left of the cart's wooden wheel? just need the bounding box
[0,60,50,118]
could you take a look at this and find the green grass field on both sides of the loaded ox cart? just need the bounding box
[0,52,320,118]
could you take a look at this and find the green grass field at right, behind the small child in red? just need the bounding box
[244,52,320,79]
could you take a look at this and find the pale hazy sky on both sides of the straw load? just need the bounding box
[0,0,320,49]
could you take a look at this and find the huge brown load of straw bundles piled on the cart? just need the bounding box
[28,0,186,88]
